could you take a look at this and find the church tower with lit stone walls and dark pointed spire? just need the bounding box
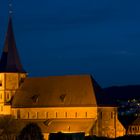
[0,15,27,115]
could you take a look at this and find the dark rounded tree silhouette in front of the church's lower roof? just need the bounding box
[17,123,44,140]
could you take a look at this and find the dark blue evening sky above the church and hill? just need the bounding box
[0,0,140,87]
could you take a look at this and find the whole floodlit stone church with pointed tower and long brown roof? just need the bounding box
[0,16,125,140]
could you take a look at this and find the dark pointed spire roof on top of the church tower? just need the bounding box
[0,17,25,72]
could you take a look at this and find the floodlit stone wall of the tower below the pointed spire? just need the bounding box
[0,73,26,115]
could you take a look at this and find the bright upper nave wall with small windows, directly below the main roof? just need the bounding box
[12,107,97,119]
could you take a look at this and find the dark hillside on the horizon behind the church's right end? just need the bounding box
[97,85,140,105]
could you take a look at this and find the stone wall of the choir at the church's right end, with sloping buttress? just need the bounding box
[93,107,125,138]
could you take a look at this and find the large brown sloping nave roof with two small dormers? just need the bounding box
[12,75,97,107]
